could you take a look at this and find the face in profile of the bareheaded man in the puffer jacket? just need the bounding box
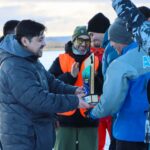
[25,34,46,57]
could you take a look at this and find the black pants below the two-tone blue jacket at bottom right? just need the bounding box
[116,140,148,150]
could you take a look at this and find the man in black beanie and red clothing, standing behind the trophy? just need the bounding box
[88,13,111,150]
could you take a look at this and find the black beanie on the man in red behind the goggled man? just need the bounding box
[88,13,110,33]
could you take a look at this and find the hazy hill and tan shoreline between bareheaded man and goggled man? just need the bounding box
[44,36,71,50]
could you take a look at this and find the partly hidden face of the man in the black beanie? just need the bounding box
[89,32,104,48]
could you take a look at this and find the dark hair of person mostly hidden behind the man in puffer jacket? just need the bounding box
[3,20,19,36]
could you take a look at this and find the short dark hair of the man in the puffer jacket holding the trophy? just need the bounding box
[16,20,46,44]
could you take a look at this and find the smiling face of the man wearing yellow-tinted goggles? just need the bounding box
[73,35,90,54]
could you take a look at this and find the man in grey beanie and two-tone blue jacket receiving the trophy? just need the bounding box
[90,14,150,150]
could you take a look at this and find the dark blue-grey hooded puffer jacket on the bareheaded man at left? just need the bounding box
[0,35,79,150]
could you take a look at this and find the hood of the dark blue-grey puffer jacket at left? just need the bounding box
[0,34,34,57]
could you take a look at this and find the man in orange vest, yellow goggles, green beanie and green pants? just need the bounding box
[49,26,102,150]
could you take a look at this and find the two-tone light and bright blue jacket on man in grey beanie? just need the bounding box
[91,48,150,142]
